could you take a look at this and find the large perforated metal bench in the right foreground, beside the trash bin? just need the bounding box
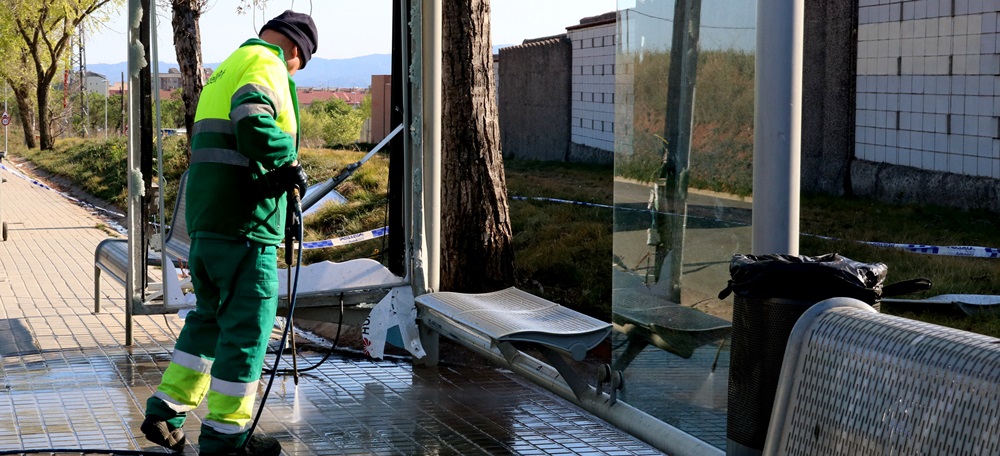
[764,298,1000,455]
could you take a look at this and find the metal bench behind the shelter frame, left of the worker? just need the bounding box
[94,172,191,314]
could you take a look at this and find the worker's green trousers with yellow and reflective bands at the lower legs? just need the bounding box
[146,237,278,453]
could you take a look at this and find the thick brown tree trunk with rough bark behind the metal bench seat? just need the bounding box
[441,0,514,293]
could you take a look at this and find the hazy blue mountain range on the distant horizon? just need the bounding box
[87,54,392,88]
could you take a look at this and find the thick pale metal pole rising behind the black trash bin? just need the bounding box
[752,0,804,255]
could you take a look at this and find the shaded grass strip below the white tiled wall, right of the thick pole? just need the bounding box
[799,195,1000,337]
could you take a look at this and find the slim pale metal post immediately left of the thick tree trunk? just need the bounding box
[421,0,441,291]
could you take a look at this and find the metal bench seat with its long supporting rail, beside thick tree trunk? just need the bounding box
[414,288,722,455]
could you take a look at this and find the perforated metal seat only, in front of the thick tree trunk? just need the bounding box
[416,288,611,360]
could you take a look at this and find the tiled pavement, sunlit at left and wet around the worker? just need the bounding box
[0,161,688,455]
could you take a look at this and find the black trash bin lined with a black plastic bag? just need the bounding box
[719,253,888,455]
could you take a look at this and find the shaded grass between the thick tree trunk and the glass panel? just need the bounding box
[505,160,614,321]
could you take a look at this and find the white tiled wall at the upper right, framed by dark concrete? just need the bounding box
[855,0,1000,178]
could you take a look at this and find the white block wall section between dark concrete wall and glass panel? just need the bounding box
[567,22,617,152]
